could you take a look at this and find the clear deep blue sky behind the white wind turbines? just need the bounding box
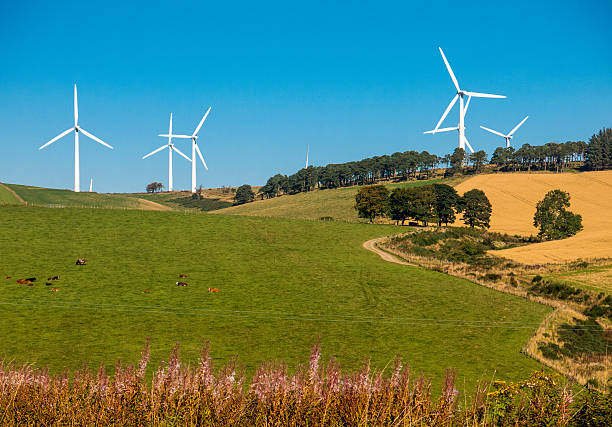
[0,0,612,192]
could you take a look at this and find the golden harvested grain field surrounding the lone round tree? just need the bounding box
[456,171,612,264]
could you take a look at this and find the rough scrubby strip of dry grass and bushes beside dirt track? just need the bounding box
[381,227,612,389]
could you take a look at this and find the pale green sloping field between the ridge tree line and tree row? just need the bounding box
[211,179,440,222]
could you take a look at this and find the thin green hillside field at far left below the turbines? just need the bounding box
[5,184,170,210]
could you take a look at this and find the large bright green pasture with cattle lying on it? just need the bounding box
[0,206,550,389]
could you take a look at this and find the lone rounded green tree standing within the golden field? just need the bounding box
[533,190,582,240]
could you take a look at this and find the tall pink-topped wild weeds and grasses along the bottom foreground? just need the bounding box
[0,344,612,426]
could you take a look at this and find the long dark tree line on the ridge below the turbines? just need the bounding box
[259,128,612,198]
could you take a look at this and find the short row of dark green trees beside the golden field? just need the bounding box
[355,184,492,228]
